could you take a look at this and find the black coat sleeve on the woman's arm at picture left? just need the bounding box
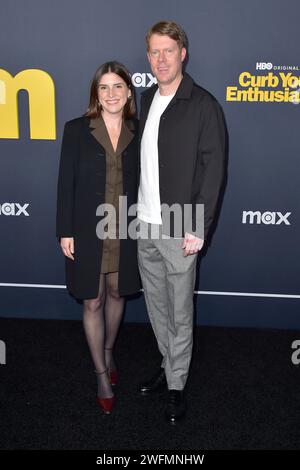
[56,122,79,238]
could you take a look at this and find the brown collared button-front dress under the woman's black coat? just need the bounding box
[91,117,133,274]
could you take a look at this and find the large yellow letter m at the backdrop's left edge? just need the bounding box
[0,69,56,140]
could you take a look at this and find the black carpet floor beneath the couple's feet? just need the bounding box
[0,319,300,450]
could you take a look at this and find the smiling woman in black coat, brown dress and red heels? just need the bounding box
[57,62,140,413]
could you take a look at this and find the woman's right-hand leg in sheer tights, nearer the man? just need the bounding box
[105,272,124,370]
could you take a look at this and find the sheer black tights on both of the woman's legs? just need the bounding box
[83,272,124,398]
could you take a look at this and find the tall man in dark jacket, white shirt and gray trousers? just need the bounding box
[138,21,225,423]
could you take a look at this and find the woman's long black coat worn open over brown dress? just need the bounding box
[56,117,140,299]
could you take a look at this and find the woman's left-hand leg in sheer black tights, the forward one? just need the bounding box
[83,274,113,398]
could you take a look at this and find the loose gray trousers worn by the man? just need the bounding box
[138,221,197,390]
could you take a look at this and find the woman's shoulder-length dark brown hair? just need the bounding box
[85,60,136,119]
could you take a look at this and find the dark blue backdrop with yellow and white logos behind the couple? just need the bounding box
[0,0,300,328]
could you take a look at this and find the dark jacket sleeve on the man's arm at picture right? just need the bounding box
[193,99,225,238]
